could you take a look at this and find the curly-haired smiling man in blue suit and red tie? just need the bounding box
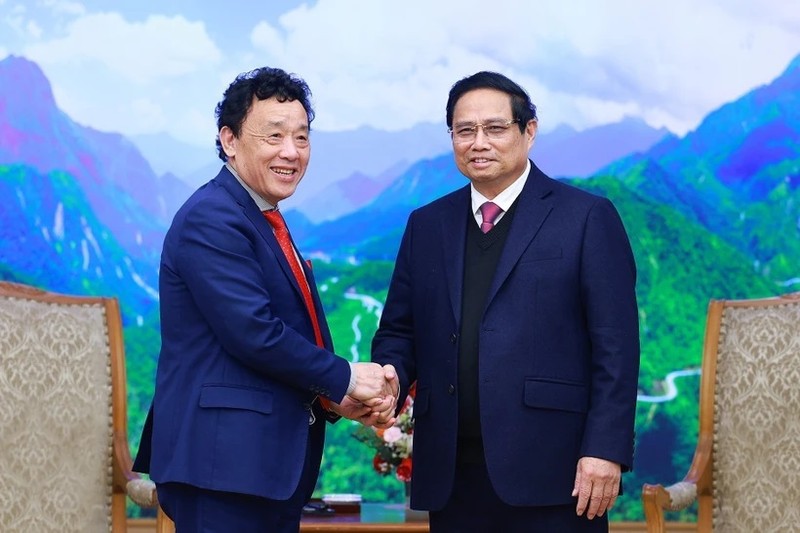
[137,68,396,533]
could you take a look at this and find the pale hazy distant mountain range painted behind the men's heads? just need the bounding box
[131,107,669,224]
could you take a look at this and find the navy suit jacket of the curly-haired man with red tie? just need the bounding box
[137,167,350,499]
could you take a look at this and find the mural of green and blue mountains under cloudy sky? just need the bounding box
[0,0,800,520]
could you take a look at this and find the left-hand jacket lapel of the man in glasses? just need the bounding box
[440,186,471,324]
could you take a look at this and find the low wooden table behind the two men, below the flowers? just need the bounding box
[300,503,429,533]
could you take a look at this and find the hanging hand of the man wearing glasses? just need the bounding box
[572,457,622,520]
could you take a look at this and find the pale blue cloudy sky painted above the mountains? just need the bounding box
[0,0,800,145]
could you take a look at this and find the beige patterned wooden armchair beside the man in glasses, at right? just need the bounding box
[642,293,800,533]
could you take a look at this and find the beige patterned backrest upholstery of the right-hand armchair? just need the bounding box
[713,300,800,532]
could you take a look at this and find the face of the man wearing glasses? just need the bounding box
[453,89,537,199]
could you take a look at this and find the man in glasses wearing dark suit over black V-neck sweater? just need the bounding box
[372,72,639,533]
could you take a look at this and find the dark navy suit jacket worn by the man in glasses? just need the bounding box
[373,166,639,510]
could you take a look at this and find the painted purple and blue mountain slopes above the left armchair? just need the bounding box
[0,56,189,424]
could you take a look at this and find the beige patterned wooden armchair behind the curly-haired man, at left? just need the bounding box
[0,282,173,533]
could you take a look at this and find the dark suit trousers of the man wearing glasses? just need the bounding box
[430,461,608,533]
